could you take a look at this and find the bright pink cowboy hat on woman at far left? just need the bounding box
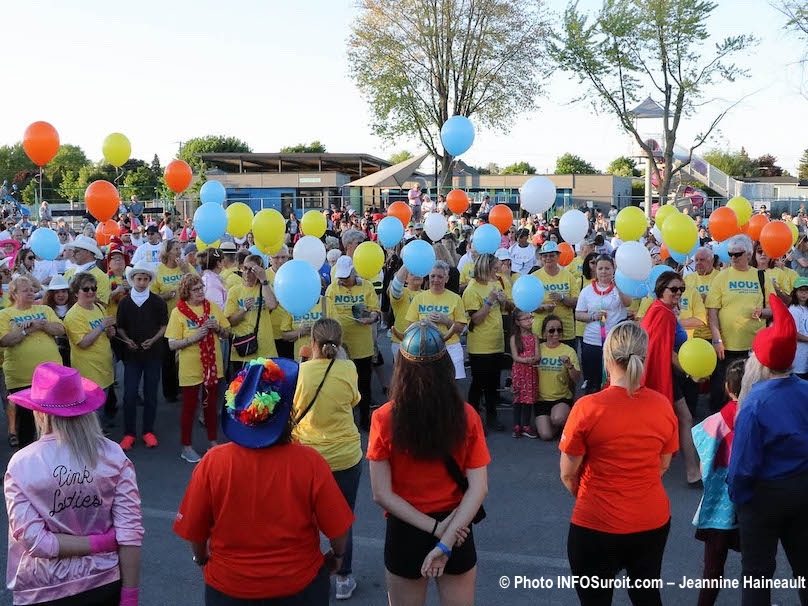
[8,362,107,417]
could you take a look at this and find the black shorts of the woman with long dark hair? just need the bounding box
[384,512,477,579]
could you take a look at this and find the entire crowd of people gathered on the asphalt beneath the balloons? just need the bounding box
[0,196,808,606]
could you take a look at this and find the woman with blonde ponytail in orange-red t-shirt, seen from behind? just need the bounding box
[559,322,679,606]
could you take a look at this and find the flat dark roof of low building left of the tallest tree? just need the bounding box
[199,153,390,178]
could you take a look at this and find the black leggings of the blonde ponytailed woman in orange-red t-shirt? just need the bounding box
[567,520,671,606]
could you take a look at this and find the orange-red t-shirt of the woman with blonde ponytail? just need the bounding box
[559,386,679,534]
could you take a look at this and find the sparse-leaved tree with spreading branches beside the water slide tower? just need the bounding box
[550,0,755,204]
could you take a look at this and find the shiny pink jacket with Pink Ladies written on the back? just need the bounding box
[4,434,143,604]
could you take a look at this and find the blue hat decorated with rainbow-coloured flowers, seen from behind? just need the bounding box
[222,358,298,448]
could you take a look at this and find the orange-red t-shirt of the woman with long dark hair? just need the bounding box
[367,402,491,513]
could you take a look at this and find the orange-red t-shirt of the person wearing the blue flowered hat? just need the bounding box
[174,443,354,600]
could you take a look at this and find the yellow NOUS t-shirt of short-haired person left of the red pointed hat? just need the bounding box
[704,267,769,351]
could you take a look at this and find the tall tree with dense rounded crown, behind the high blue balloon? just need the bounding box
[348,0,548,185]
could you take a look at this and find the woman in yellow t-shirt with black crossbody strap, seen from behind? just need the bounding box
[292,318,362,600]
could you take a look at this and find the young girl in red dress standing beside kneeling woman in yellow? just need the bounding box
[510,309,539,439]
